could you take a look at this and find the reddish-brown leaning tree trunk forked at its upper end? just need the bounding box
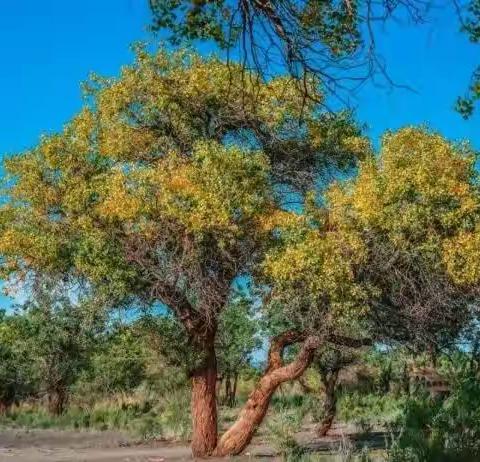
[213,331,320,457]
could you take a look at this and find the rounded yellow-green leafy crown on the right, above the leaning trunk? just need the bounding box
[263,128,480,440]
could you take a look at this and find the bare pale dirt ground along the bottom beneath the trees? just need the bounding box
[0,426,381,462]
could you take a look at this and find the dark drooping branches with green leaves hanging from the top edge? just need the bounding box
[149,0,480,118]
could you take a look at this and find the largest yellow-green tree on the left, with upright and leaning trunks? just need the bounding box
[0,49,365,456]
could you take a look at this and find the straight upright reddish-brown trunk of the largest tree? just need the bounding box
[191,338,217,457]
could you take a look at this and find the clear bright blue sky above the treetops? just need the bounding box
[0,0,480,304]
